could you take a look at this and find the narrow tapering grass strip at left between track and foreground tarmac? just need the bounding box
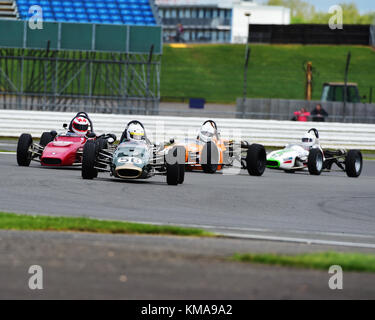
[0,212,215,237]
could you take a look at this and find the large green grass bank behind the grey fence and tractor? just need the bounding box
[161,45,375,104]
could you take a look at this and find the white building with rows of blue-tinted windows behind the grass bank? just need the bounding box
[155,0,291,43]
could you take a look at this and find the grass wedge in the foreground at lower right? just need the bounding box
[231,252,375,272]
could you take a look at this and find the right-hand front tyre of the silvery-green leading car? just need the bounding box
[166,146,186,186]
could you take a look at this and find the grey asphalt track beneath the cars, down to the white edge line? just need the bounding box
[0,154,375,243]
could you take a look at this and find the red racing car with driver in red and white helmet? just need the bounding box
[17,112,116,167]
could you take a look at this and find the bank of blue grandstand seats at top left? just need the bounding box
[16,0,157,26]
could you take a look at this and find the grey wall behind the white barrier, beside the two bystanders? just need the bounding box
[236,98,375,123]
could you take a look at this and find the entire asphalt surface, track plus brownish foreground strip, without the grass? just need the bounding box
[0,153,375,299]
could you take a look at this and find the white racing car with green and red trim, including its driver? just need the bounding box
[267,129,363,178]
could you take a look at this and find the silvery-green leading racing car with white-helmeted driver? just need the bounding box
[82,120,186,185]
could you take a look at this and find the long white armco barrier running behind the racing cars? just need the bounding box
[0,110,375,150]
